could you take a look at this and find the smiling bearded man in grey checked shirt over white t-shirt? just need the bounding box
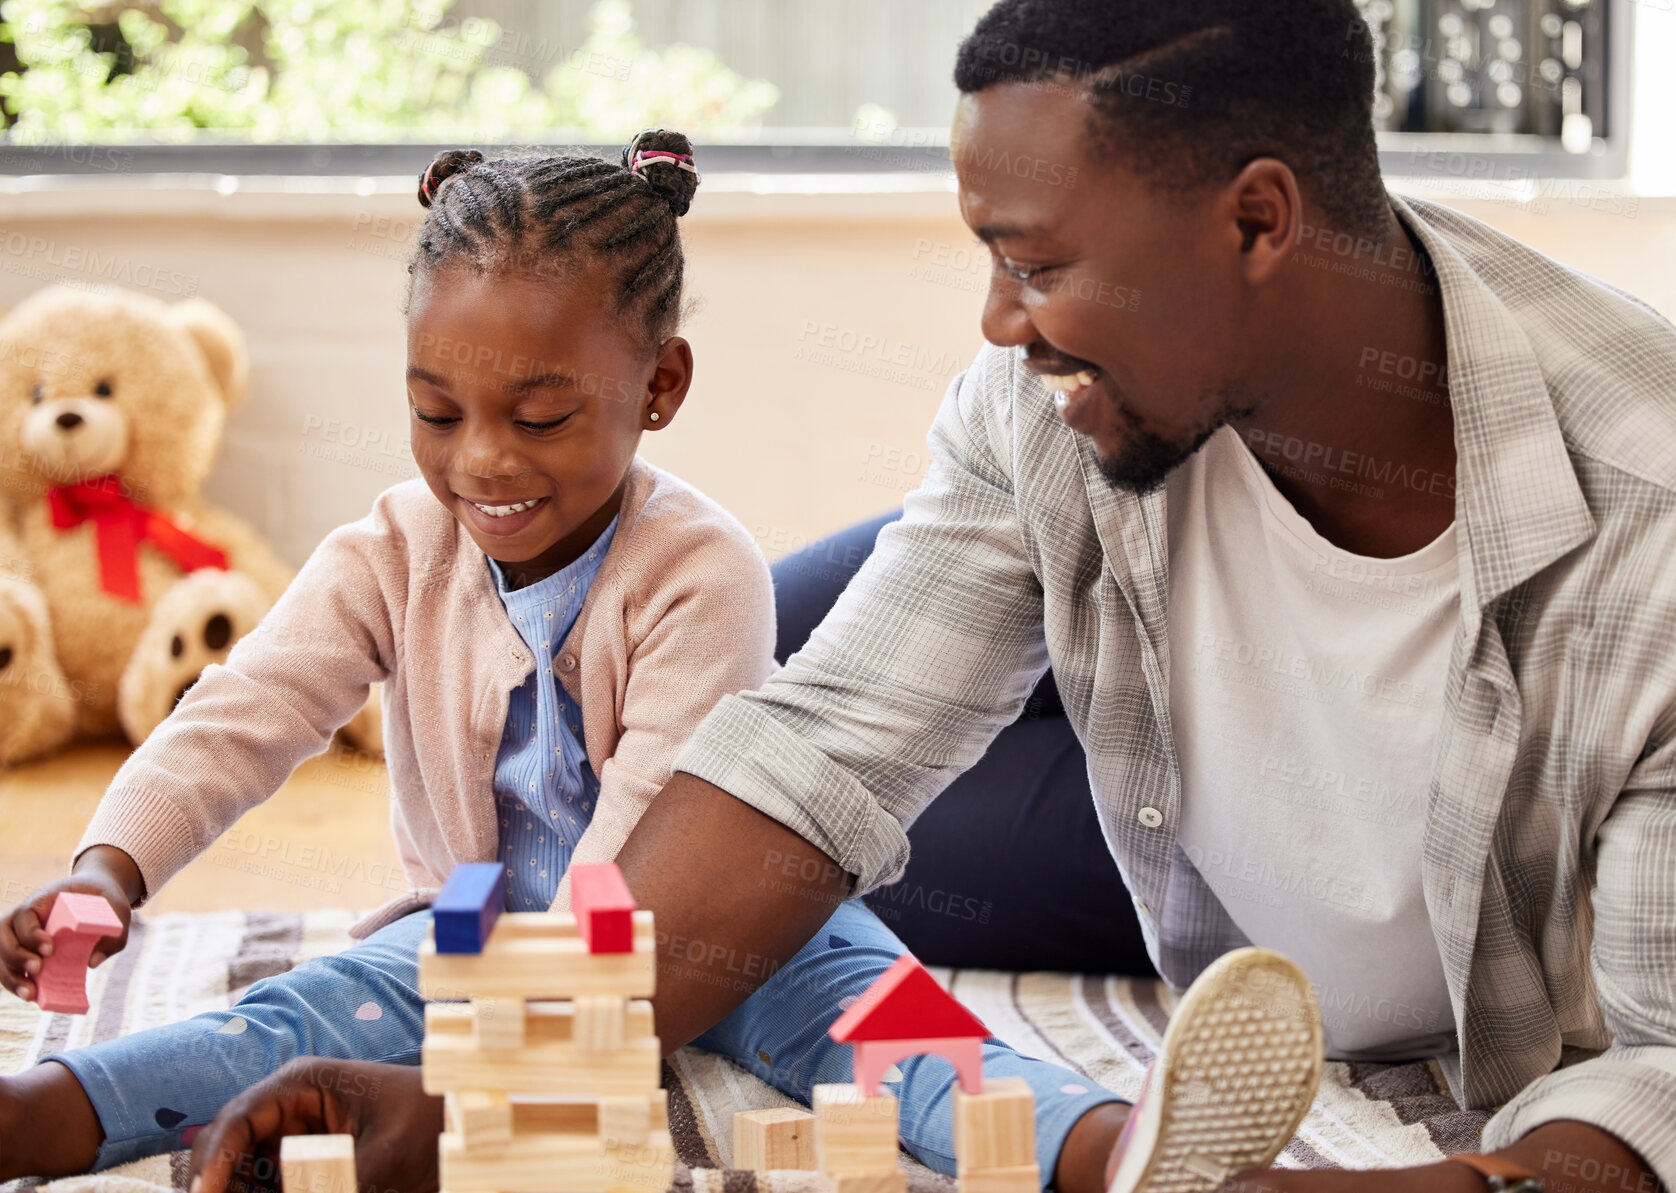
[192,0,1676,1191]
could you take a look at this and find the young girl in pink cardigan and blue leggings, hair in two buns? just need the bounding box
[0,132,1121,1183]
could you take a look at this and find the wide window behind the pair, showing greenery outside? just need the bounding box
[0,0,1629,176]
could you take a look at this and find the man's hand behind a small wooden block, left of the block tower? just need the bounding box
[191,1057,442,1193]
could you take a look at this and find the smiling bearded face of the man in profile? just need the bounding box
[952,80,1250,493]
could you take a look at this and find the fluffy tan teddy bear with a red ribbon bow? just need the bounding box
[0,287,380,764]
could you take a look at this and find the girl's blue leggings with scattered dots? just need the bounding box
[50,901,1120,1185]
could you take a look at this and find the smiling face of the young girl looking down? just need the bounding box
[407,268,692,586]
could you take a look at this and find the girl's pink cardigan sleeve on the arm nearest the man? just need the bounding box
[553,518,774,912]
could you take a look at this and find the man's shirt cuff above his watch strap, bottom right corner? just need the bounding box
[1483,1046,1676,1188]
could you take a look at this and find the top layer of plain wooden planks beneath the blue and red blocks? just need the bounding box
[419,912,657,1000]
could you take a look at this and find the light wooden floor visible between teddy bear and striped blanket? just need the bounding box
[0,746,407,912]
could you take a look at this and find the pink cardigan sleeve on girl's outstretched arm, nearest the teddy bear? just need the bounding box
[75,494,406,896]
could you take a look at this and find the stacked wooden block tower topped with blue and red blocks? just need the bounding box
[419,863,675,1193]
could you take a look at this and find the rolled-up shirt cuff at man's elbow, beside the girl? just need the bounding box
[674,695,908,895]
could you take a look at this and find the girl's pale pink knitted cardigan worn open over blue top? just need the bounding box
[77,459,774,937]
